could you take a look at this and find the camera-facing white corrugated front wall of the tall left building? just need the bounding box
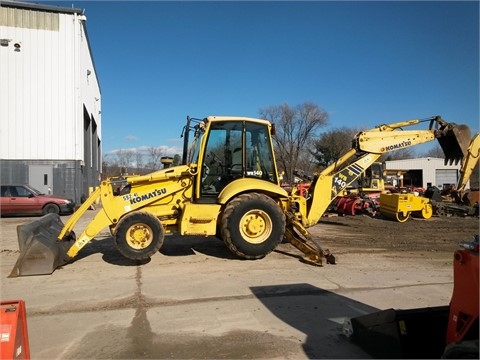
[0,8,79,159]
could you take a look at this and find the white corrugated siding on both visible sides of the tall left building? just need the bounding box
[0,7,101,160]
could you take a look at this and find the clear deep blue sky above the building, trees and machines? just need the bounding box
[36,1,479,155]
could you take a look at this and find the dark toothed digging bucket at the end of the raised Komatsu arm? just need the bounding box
[437,124,471,165]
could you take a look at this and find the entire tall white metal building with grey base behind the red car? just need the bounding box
[0,0,102,202]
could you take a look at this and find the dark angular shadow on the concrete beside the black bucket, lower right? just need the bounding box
[250,283,378,359]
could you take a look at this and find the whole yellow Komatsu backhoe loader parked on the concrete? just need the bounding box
[10,116,470,277]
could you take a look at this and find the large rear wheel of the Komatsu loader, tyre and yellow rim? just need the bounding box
[221,193,285,259]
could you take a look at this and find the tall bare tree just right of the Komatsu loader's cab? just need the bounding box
[259,102,328,182]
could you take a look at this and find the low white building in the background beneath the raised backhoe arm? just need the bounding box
[385,157,468,189]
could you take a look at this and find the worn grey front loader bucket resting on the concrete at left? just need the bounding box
[9,214,72,277]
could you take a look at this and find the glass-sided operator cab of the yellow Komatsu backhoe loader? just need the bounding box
[183,117,278,200]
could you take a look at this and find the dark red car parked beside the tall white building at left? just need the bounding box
[0,185,75,215]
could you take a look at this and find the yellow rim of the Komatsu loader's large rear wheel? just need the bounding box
[239,210,272,244]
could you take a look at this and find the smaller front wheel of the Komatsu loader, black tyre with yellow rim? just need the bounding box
[115,212,164,260]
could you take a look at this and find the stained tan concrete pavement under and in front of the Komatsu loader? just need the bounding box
[0,210,452,359]
